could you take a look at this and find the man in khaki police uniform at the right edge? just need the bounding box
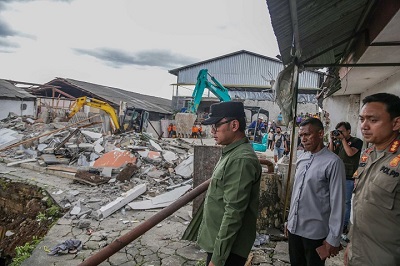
[344,93,400,266]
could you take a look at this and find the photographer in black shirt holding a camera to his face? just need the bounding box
[329,122,363,234]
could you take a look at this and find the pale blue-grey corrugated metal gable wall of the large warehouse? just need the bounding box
[169,50,322,90]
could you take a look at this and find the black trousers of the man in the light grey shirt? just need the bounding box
[289,232,325,266]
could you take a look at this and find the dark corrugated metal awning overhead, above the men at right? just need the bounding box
[266,0,376,64]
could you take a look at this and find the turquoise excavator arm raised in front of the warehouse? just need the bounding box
[189,69,231,113]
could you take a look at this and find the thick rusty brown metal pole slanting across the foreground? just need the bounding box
[79,179,211,266]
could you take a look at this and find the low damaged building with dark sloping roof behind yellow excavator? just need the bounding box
[28,78,172,135]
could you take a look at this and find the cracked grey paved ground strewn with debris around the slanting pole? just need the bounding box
[0,161,343,266]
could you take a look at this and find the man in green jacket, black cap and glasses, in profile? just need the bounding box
[197,102,261,266]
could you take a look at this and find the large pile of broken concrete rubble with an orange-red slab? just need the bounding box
[0,116,199,223]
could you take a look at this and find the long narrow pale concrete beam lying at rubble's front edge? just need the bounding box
[97,184,146,219]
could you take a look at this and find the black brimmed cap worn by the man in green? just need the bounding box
[202,102,246,125]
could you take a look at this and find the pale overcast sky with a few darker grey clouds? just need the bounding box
[0,0,279,99]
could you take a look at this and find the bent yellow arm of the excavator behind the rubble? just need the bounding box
[68,96,120,132]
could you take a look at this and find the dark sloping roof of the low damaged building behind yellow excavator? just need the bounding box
[47,78,172,114]
